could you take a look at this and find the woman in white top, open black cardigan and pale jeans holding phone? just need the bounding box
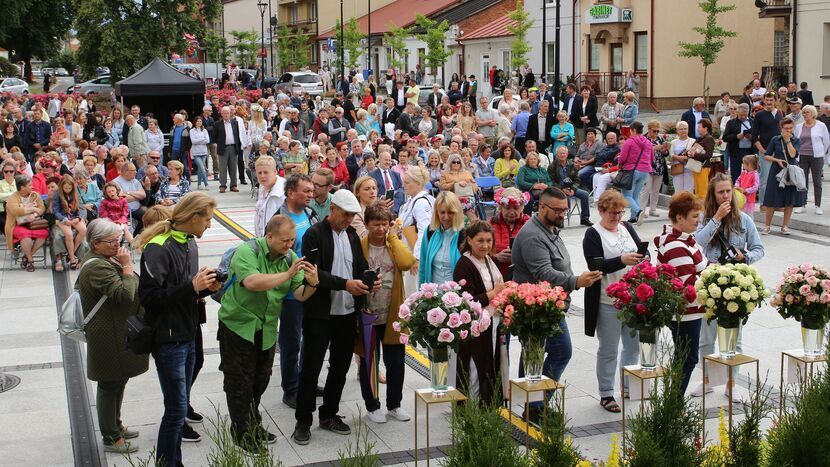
[582,190,648,413]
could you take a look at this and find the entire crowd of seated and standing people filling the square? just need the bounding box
[0,67,830,465]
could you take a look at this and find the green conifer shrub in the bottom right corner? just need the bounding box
[761,342,830,467]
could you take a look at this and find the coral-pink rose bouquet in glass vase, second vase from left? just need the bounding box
[490,281,568,382]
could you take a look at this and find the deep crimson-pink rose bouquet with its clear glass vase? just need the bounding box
[606,261,697,371]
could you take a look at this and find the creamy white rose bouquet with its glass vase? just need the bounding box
[695,263,771,358]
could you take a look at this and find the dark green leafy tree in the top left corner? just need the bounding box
[0,0,75,80]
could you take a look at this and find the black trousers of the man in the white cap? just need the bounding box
[294,313,357,427]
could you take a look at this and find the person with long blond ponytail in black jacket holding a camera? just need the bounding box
[138,192,222,467]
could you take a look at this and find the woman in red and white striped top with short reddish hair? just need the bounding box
[654,191,708,392]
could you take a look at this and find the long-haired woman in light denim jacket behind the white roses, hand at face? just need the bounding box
[692,173,764,401]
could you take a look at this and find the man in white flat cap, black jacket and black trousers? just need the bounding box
[291,190,379,445]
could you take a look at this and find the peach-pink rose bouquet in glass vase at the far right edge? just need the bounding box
[770,263,830,357]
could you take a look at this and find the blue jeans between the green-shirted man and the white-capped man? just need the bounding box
[277,299,303,397]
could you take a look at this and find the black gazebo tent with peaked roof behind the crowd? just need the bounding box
[115,58,205,132]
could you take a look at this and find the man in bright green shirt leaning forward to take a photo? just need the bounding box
[219,215,318,452]
